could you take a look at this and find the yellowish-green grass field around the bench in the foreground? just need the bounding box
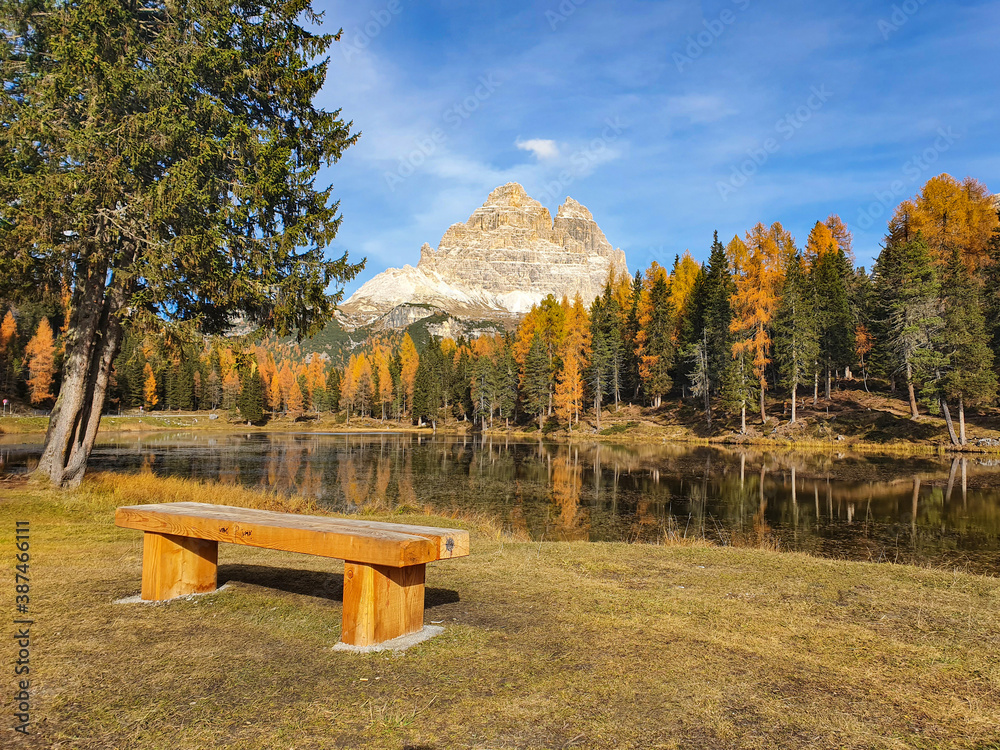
[0,475,1000,750]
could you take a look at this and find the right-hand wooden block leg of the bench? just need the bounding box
[340,560,427,646]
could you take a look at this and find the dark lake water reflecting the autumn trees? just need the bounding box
[0,433,1000,575]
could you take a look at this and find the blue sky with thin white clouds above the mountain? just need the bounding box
[315,0,1000,294]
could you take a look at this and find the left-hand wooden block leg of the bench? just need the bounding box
[141,531,219,601]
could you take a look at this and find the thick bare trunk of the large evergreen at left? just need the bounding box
[35,264,126,487]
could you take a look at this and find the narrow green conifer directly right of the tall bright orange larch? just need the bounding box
[774,254,823,424]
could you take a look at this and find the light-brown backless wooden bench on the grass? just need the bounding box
[115,503,469,646]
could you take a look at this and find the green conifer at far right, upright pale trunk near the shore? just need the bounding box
[941,248,997,445]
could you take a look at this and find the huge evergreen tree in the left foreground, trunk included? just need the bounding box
[0,0,361,486]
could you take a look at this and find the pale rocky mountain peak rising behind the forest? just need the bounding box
[338,182,628,329]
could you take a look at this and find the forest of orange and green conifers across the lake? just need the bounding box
[0,174,1000,445]
